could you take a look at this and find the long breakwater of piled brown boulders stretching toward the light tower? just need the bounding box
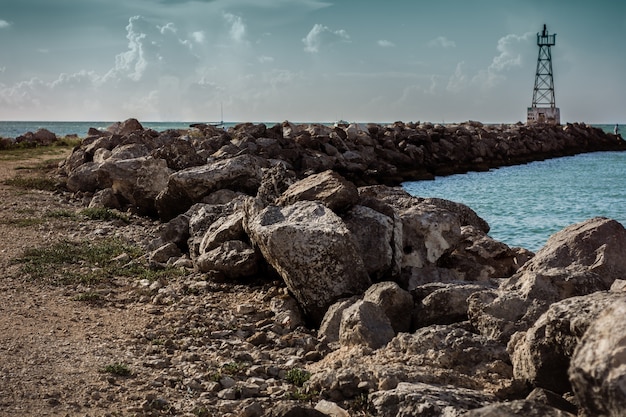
[61,121,626,416]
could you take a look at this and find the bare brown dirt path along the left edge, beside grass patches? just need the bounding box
[0,149,151,416]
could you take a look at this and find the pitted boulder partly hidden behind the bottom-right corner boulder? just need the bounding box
[508,292,626,394]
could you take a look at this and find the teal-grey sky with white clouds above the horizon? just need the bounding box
[0,0,626,123]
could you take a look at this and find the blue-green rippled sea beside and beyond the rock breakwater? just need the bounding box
[0,121,626,252]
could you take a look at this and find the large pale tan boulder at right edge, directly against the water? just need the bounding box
[505,217,626,302]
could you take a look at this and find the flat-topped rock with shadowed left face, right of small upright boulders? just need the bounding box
[412,283,490,328]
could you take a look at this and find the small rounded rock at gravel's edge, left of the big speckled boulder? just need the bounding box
[195,240,258,279]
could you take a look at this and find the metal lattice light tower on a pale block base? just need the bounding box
[526,25,561,125]
